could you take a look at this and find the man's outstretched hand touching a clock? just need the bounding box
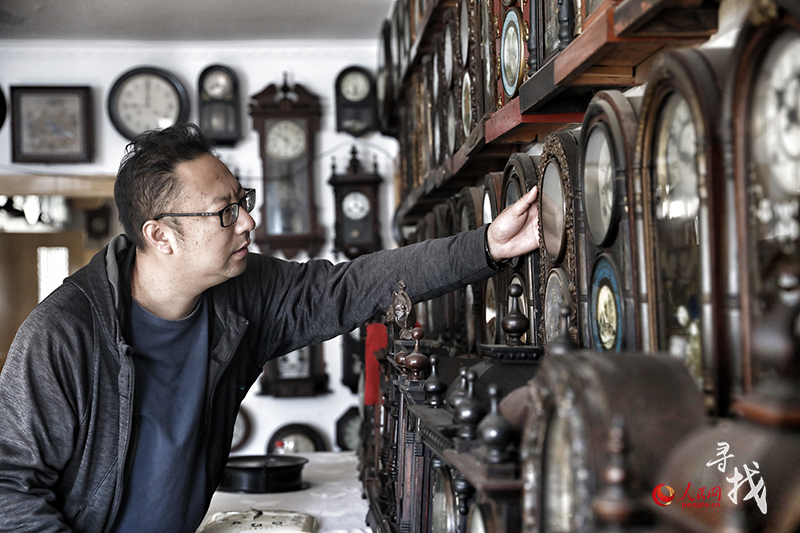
[486,187,539,261]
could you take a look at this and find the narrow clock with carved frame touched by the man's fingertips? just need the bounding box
[537,130,588,344]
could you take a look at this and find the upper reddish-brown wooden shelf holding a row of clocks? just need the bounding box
[391,0,717,234]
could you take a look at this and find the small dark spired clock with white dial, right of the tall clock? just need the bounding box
[328,146,383,259]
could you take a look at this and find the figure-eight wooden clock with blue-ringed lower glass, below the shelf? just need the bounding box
[575,91,641,351]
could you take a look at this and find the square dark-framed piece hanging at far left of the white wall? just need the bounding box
[11,86,94,163]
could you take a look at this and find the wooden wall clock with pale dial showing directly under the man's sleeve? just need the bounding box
[259,345,328,398]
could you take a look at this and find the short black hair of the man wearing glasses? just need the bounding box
[114,124,214,250]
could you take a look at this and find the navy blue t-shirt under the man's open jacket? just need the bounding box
[113,298,208,533]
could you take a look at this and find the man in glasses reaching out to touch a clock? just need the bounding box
[0,125,538,532]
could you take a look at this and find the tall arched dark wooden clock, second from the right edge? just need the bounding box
[637,49,725,408]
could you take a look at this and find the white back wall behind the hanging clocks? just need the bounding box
[0,34,397,453]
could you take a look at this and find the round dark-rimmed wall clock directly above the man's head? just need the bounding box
[107,67,189,140]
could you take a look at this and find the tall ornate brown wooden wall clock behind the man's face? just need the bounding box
[250,74,325,258]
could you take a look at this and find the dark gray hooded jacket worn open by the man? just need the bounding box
[0,228,494,533]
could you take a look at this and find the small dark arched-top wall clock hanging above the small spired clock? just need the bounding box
[336,66,378,137]
